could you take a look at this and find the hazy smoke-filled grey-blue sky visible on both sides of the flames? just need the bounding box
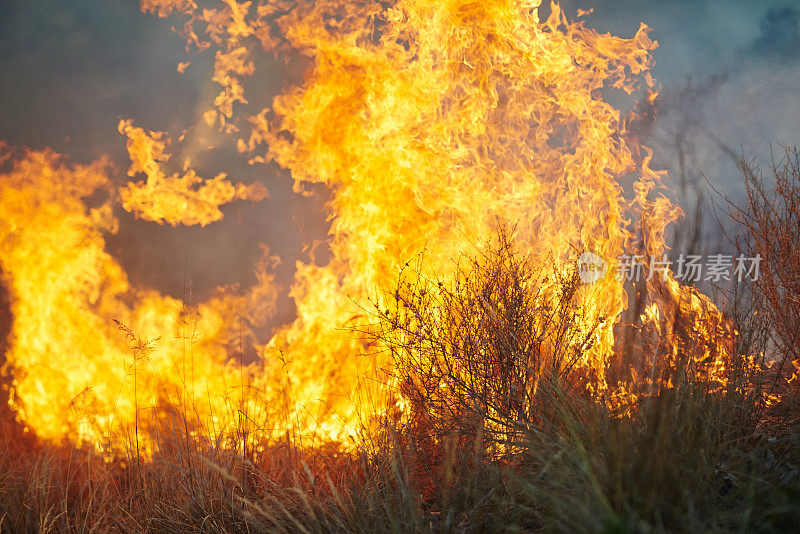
[0,0,800,308]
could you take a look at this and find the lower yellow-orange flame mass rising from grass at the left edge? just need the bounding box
[0,143,275,448]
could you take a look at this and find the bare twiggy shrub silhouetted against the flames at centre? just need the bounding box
[372,231,599,464]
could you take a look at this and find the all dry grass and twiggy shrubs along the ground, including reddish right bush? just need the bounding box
[0,151,800,533]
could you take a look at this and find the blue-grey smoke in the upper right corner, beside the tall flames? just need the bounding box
[574,0,800,260]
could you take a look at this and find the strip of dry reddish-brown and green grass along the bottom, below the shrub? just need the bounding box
[0,360,800,532]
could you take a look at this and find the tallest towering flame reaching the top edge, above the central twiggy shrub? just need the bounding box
[240,1,656,406]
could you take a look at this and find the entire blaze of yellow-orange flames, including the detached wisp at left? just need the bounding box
[0,0,732,454]
